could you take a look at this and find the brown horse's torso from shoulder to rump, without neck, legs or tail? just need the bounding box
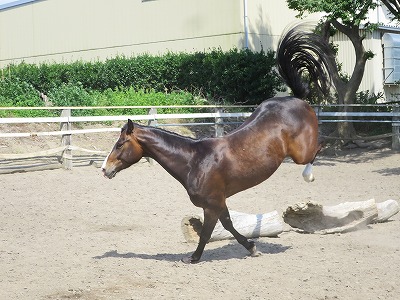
[187,97,318,202]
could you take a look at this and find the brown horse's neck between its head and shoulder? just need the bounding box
[138,127,195,184]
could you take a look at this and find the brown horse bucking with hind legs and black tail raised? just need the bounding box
[102,26,331,263]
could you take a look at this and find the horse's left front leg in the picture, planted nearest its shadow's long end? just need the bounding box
[182,208,221,264]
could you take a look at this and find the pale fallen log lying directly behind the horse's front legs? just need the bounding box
[181,211,284,243]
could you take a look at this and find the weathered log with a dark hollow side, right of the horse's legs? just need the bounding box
[283,199,399,234]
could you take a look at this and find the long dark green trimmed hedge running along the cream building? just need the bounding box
[0,49,283,105]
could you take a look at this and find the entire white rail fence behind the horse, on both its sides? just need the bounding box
[0,105,400,169]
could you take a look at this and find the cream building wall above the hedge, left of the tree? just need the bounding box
[0,0,318,67]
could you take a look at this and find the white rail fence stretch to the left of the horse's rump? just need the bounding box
[0,105,253,169]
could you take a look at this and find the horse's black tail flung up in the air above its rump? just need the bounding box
[277,24,334,99]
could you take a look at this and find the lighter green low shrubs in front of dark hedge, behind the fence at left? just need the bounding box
[0,79,208,117]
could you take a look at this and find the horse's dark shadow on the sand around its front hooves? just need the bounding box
[93,242,291,262]
